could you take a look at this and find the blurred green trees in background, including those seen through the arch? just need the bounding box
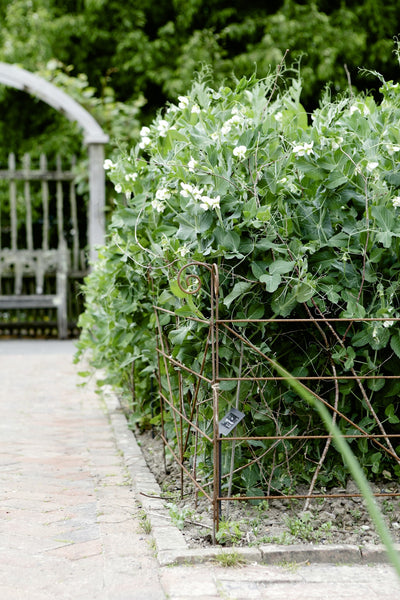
[0,0,400,225]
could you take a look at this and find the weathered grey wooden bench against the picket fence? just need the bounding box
[0,242,68,339]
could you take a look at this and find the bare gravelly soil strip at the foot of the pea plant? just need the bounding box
[135,431,400,548]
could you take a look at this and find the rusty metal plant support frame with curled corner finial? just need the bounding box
[154,262,400,543]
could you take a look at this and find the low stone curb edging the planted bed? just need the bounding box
[102,388,400,566]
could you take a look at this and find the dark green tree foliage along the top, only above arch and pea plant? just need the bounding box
[0,0,400,116]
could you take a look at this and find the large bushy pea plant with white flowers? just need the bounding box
[78,58,400,495]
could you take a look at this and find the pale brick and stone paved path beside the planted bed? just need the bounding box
[0,340,400,600]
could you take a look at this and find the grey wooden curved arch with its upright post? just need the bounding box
[0,62,108,262]
